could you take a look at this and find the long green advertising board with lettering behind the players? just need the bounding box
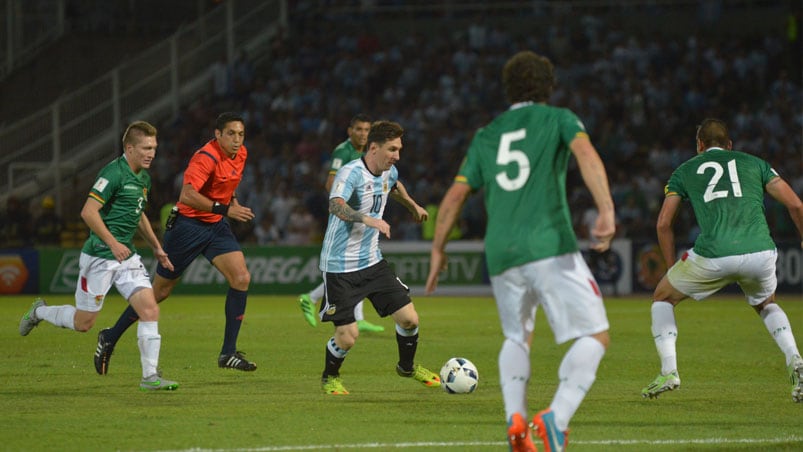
[40,240,632,296]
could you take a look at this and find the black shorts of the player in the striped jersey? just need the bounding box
[321,259,412,326]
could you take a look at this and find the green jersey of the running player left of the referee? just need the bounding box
[81,156,151,259]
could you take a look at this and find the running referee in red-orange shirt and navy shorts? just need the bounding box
[94,112,257,375]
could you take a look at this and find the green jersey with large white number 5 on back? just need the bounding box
[455,102,587,275]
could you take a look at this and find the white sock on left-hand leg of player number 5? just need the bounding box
[499,339,530,420]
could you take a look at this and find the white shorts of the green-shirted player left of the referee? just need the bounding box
[75,252,151,312]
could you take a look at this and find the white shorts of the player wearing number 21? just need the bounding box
[666,250,778,306]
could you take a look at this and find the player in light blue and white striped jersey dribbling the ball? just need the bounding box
[320,121,440,394]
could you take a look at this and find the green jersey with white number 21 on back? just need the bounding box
[664,148,778,258]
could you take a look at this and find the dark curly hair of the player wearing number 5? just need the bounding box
[502,50,555,104]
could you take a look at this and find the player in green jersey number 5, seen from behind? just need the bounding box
[426,51,615,451]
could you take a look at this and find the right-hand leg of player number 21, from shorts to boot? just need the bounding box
[738,250,803,402]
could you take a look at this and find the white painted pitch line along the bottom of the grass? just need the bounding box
[155,435,803,452]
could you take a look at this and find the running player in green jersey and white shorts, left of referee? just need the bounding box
[20,121,178,391]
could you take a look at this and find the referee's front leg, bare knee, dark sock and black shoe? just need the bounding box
[212,250,257,371]
